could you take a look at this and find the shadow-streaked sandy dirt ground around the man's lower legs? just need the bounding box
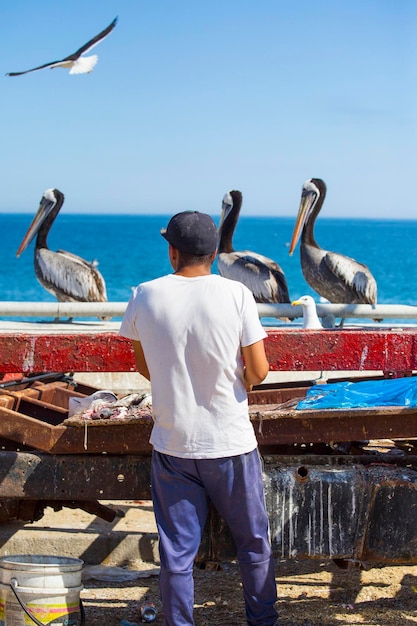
[81,560,417,626]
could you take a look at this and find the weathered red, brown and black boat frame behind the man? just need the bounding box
[0,324,417,566]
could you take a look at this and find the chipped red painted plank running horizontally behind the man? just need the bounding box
[0,328,417,375]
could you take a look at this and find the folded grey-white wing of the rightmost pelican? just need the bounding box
[323,252,377,304]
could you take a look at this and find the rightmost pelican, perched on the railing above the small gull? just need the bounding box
[289,178,377,304]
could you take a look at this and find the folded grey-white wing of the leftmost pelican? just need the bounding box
[37,248,107,302]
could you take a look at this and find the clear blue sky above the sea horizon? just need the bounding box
[0,0,417,219]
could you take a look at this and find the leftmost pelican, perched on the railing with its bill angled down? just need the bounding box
[16,189,107,302]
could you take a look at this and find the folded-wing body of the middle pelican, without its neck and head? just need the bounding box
[218,250,290,302]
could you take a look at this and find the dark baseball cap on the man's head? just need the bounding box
[161,211,217,255]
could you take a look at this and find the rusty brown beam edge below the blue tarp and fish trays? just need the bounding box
[0,401,417,456]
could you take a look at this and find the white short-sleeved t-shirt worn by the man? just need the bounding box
[120,274,266,459]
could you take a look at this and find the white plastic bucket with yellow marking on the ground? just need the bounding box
[0,554,84,626]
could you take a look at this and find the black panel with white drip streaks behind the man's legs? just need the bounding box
[199,456,417,567]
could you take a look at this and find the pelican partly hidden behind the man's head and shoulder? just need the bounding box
[217,190,290,303]
